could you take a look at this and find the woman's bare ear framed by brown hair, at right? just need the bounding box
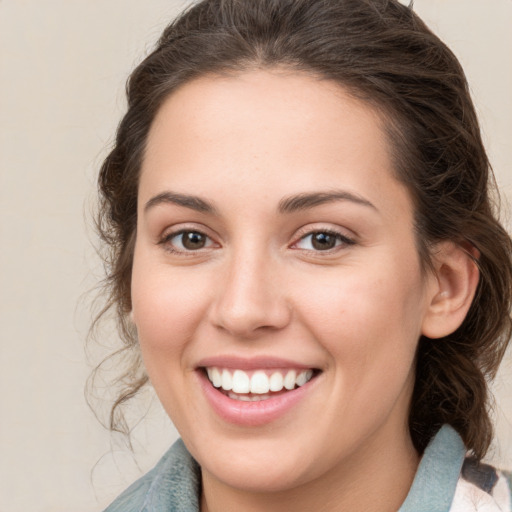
[422,242,480,338]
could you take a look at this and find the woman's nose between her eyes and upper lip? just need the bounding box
[212,253,292,339]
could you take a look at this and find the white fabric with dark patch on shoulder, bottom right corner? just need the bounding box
[450,458,512,512]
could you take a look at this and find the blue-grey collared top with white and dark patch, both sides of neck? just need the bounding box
[104,425,512,512]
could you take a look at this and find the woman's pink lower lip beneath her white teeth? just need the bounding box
[196,370,317,427]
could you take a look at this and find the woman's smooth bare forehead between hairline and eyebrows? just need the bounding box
[140,70,412,220]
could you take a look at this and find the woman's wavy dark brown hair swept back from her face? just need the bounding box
[94,0,512,458]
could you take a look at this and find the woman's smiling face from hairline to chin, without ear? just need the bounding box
[132,71,431,490]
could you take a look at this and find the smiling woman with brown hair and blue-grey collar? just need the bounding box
[99,0,512,512]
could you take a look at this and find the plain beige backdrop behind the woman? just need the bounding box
[0,0,512,512]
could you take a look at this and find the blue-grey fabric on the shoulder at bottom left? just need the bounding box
[104,440,200,512]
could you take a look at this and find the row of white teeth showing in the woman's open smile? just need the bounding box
[204,367,320,402]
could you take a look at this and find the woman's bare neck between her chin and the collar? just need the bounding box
[201,425,419,512]
